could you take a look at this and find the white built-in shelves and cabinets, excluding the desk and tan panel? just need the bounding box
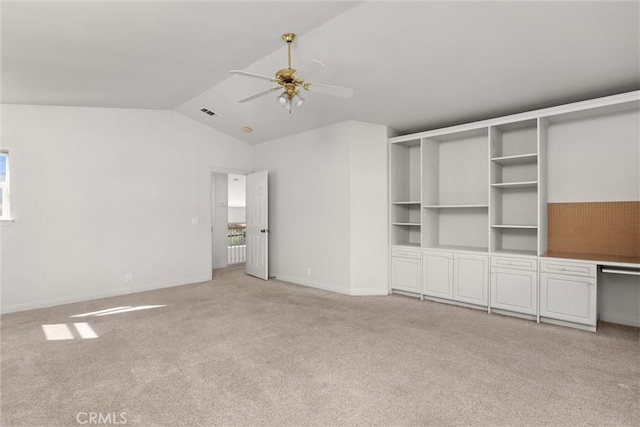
[389,92,640,332]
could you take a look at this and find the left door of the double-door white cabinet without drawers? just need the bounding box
[422,252,453,299]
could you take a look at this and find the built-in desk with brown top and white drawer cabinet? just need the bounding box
[539,252,640,331]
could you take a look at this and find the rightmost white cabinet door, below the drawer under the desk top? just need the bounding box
[540,273,597,326]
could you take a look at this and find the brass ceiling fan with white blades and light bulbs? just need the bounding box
[230,33,353,113]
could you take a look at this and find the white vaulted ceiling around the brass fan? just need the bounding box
[1,1,640,143]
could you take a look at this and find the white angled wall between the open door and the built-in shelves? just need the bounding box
[253,121,387,295]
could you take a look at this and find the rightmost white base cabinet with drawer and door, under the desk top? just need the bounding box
[540,260,597,327]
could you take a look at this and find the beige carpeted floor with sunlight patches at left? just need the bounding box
[0,267,640,427]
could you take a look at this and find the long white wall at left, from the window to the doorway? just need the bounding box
[1,105,251,312]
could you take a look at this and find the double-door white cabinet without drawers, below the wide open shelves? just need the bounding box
[422,251,488,306]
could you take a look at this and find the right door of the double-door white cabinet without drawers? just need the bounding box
[453,254,489,306]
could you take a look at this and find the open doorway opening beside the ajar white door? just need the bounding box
[211,172,246,269]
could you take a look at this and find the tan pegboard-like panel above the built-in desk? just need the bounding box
[547,202,640,257]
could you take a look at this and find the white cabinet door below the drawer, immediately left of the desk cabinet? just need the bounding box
[491,269,538,315]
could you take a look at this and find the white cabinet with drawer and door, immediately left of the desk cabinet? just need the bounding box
[491,256,538,315]
